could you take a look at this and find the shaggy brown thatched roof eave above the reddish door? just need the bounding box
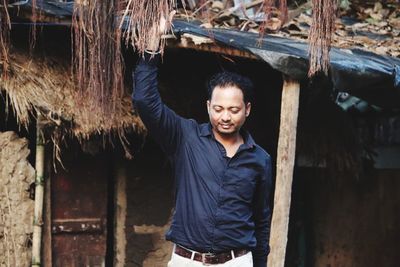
[0,51,145,146]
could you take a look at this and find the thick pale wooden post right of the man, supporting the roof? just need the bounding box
[268,76,300,267]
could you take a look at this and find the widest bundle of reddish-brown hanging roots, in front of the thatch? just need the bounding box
[72,0,123,118]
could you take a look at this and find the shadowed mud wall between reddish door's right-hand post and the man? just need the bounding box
[125,148,173,267]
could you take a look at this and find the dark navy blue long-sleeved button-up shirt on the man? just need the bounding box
[133,57,271,267]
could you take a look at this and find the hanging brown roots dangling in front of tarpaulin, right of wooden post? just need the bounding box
[308,0,337,77]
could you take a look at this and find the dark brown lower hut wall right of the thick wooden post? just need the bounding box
[286,169,400,267]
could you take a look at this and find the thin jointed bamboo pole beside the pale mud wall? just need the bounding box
[32,113,45,267]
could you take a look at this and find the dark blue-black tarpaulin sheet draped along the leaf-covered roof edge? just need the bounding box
[174,20,400,108]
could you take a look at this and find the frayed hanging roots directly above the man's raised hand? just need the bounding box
[123,0,175,55]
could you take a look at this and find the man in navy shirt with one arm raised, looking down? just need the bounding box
[133,18,271,267]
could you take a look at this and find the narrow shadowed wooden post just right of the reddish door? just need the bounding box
[114,157,127,267]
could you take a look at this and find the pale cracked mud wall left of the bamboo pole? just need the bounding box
[0,131,35,267]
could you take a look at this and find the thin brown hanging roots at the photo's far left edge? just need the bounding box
[0,0,11,77]
